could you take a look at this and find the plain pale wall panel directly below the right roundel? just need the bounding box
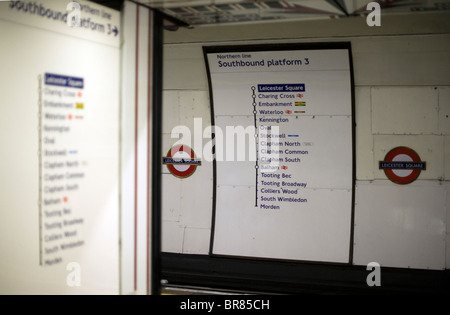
[354,180,446,270]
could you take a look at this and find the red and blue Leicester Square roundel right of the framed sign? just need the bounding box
[379,147,426,184]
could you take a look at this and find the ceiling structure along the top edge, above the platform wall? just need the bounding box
[94,0,450,26]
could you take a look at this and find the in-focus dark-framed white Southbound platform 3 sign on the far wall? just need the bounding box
[204,43,354,263]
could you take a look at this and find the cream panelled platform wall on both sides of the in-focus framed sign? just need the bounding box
[163,12,450,269]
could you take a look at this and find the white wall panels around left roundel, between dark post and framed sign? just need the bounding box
[162,88,213,254]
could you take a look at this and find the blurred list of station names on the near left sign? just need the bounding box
[39,73,86,266]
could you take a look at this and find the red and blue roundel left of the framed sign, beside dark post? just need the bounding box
[163,145,202,178]
